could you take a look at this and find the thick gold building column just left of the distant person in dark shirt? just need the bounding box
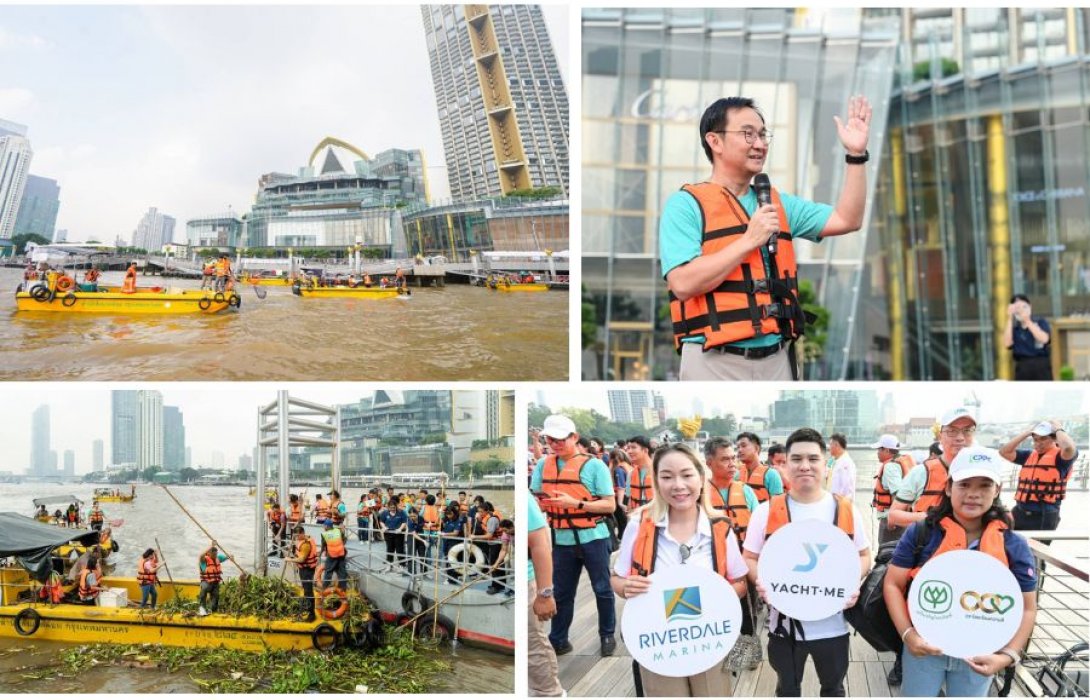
[986,114,1014,379]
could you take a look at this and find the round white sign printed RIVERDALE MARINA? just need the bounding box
[620,566,742,677]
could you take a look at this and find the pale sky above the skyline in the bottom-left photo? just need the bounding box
[0,383,383,474]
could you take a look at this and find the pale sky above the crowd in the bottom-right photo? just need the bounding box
[531,382,1087,426]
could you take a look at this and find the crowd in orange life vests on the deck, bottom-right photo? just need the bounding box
[528,407,1077,697]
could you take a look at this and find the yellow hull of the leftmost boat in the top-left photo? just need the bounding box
[15,290,231,314]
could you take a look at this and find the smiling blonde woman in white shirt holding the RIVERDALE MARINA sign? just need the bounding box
[610,444,748,697]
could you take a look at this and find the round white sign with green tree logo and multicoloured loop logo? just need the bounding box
[908,550,1024,659]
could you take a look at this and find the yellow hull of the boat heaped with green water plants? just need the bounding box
[0,568,343,652]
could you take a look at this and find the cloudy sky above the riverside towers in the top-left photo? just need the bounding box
[0,3,571,243]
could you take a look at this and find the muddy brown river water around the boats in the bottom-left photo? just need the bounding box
[0,483,514,693]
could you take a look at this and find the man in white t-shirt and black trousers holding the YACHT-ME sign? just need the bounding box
[742,427,871,698]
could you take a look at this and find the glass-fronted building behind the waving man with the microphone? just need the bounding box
[582,9,1090,379]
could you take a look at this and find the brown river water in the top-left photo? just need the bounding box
[0,268,568,382]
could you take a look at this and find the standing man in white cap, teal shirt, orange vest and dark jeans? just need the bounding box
[530,414,617,656]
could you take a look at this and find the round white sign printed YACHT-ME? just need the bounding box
[756,520,860,620]
